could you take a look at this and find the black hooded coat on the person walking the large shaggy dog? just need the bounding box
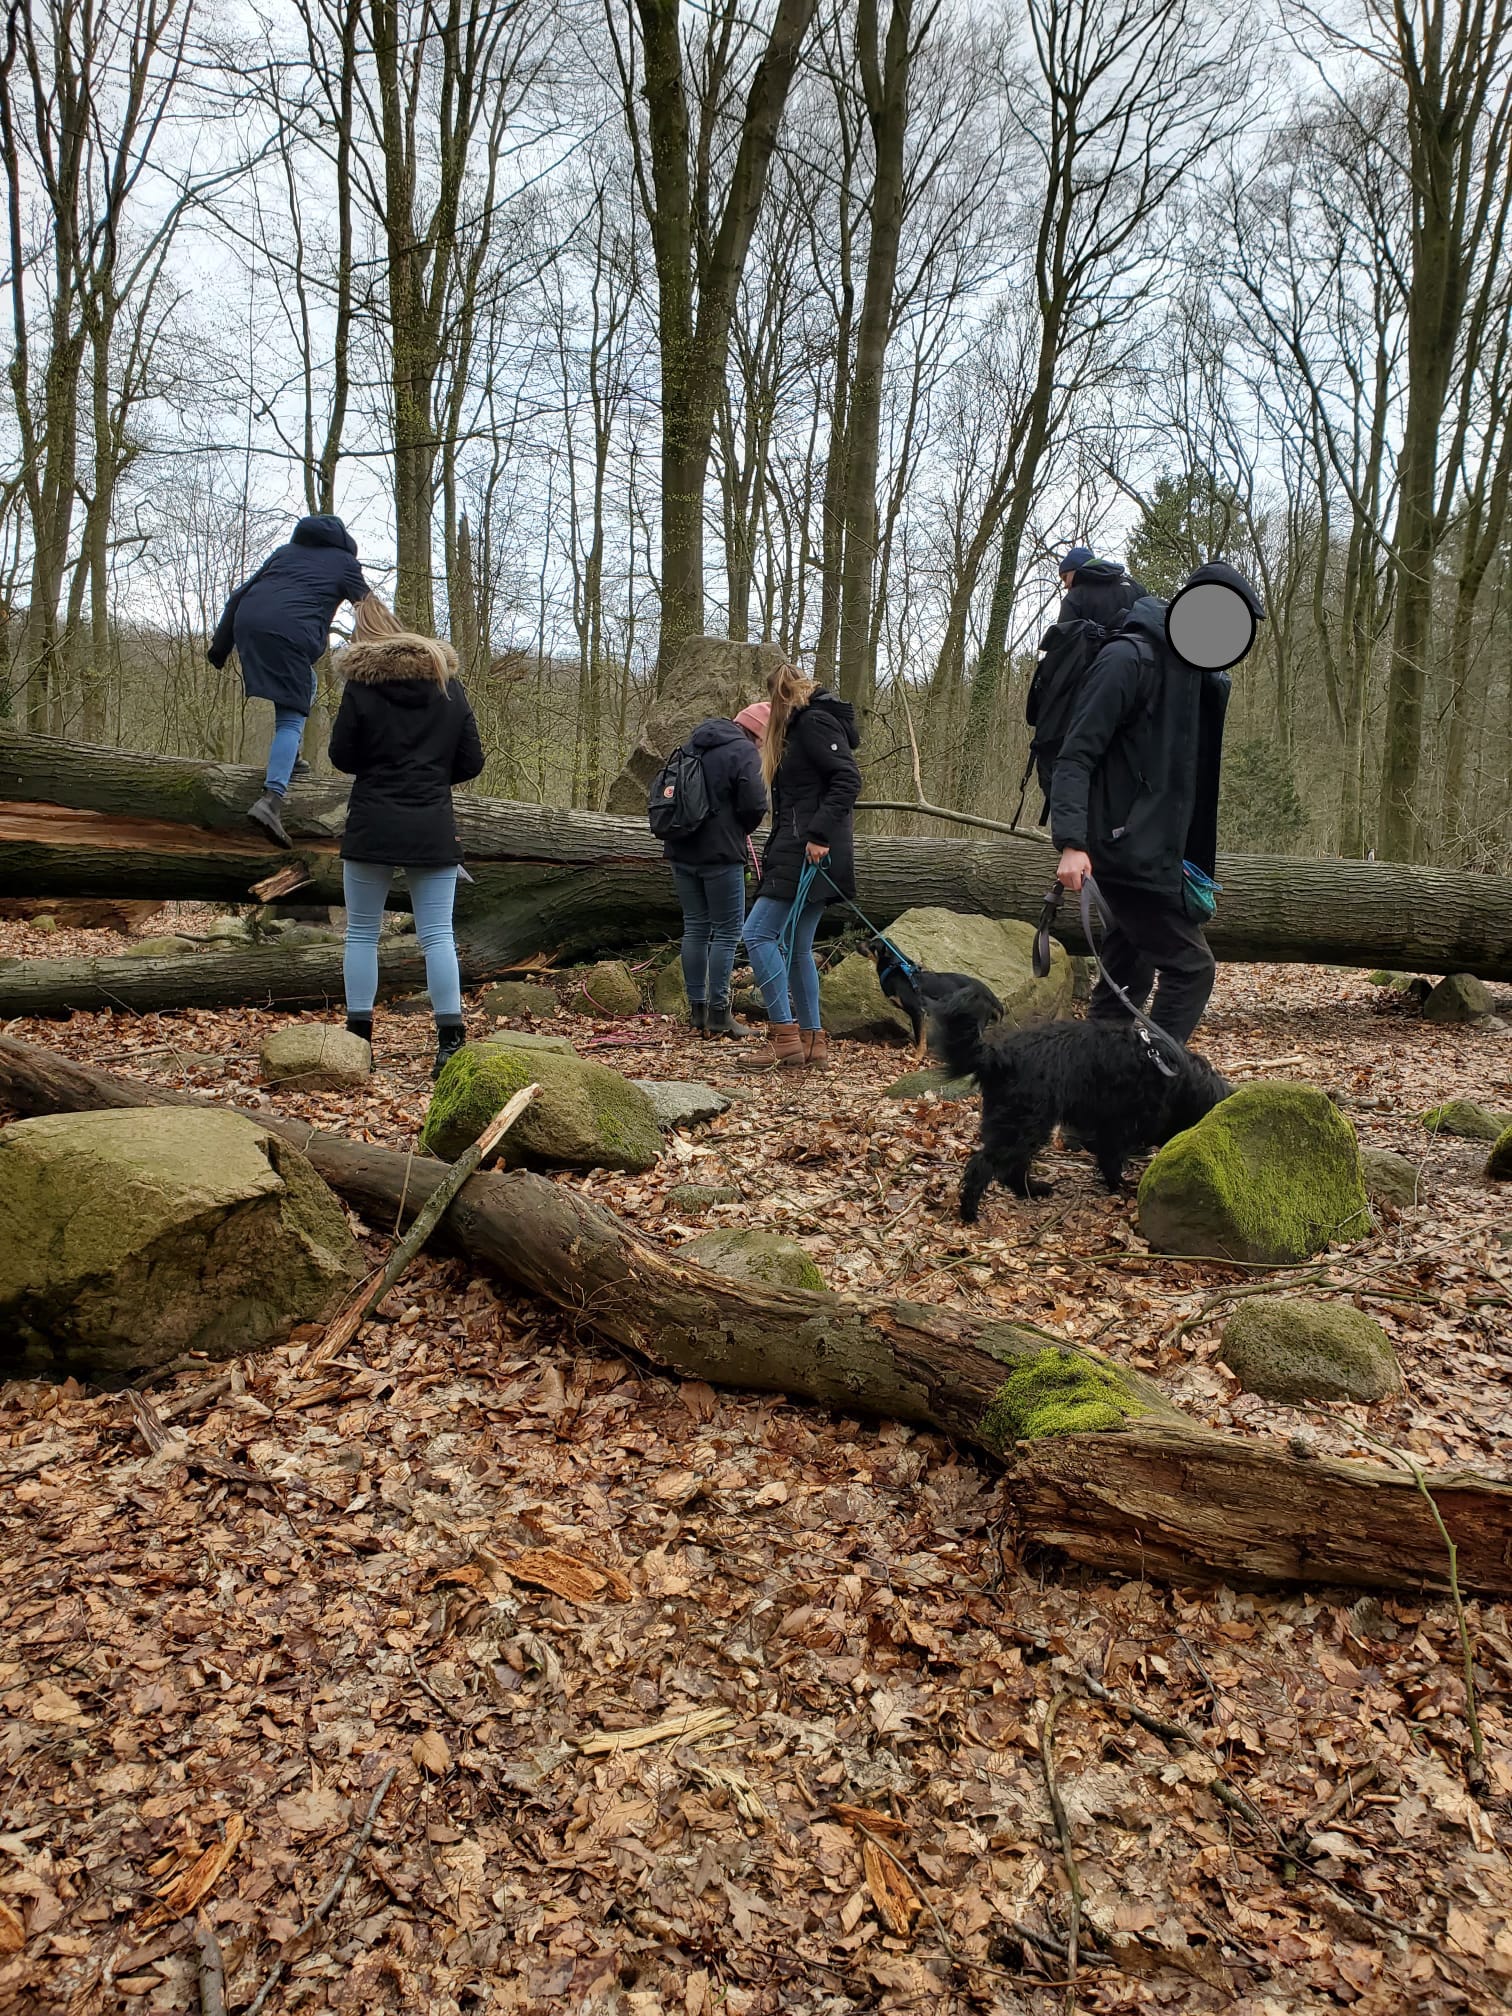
[1050,595,1230,903]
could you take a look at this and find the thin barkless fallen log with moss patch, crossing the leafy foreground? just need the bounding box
[0,1036,1512,1597]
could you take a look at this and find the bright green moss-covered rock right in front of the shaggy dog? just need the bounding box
[1139,1085,1371,1262]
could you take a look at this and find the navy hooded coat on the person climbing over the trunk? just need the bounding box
[206,518,369,714]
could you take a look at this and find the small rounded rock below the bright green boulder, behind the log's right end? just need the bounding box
[1218,1294,1401,1401]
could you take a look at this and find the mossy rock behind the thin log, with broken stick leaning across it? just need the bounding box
[419,1038,661,1171]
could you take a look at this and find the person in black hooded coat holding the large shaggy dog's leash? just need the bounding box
[1050,560,1266,1042]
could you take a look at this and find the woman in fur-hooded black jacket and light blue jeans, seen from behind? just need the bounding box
[331,595,484,1077]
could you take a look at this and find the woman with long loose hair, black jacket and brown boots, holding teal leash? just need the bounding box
[742,665,861,1070]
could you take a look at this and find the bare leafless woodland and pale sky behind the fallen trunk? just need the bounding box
[0,0,1512,869]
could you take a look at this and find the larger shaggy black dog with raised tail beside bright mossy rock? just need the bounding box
[933,1002,1234,1226]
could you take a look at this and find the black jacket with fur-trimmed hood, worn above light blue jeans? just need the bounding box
[331,637,484,869]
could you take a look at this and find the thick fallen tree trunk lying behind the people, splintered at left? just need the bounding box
[0,730,1512,983]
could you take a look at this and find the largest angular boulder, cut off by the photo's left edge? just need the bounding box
[0,1107,363,1385]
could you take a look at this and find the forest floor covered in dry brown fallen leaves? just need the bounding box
[0,917,1512,2016]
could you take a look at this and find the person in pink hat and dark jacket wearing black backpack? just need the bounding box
[661,700,768,1036]
